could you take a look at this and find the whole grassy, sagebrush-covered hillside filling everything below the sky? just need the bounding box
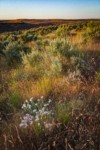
[0,20,100,150]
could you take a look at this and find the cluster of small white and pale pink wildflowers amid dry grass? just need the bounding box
[19,96,53,128]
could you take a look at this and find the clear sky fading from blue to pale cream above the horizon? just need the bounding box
[0,0,100,20]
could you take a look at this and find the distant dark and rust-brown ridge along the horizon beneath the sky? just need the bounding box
[0,19,100,33]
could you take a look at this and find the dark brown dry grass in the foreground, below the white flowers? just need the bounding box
[0,96,100,150]
